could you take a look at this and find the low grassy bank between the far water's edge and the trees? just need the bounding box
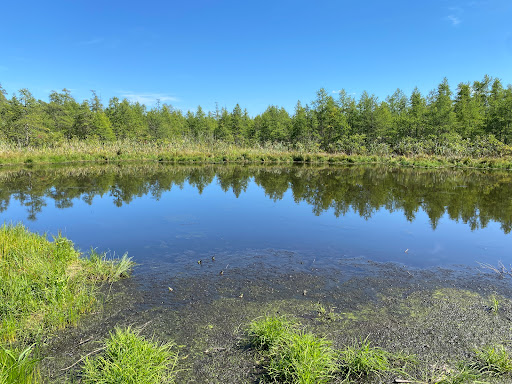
[0,140,512,169]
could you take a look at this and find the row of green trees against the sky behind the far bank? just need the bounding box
[0,75,512,154]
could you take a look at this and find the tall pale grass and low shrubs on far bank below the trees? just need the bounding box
[0,136,512,169]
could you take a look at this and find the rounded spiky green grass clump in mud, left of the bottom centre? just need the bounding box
[81,328,178,384]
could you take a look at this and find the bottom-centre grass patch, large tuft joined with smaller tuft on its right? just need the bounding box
[247,317,417,384]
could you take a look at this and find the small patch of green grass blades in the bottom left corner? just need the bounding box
[0,344,41,384]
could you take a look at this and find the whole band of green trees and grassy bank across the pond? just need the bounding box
[0,75,512,169]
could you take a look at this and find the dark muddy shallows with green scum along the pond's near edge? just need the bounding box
[42,260,512,383]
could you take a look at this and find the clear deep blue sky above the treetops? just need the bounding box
[0,0,512,116]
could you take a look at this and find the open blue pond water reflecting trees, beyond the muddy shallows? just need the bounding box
[0,164,512,273]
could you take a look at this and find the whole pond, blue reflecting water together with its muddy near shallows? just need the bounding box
[0,163,512,383]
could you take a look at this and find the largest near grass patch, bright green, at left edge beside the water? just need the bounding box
[0,224,133,342]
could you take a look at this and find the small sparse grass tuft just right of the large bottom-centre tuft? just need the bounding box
[340,338,417,382]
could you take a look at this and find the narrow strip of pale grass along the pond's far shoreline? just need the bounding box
[0,142,512,170]
